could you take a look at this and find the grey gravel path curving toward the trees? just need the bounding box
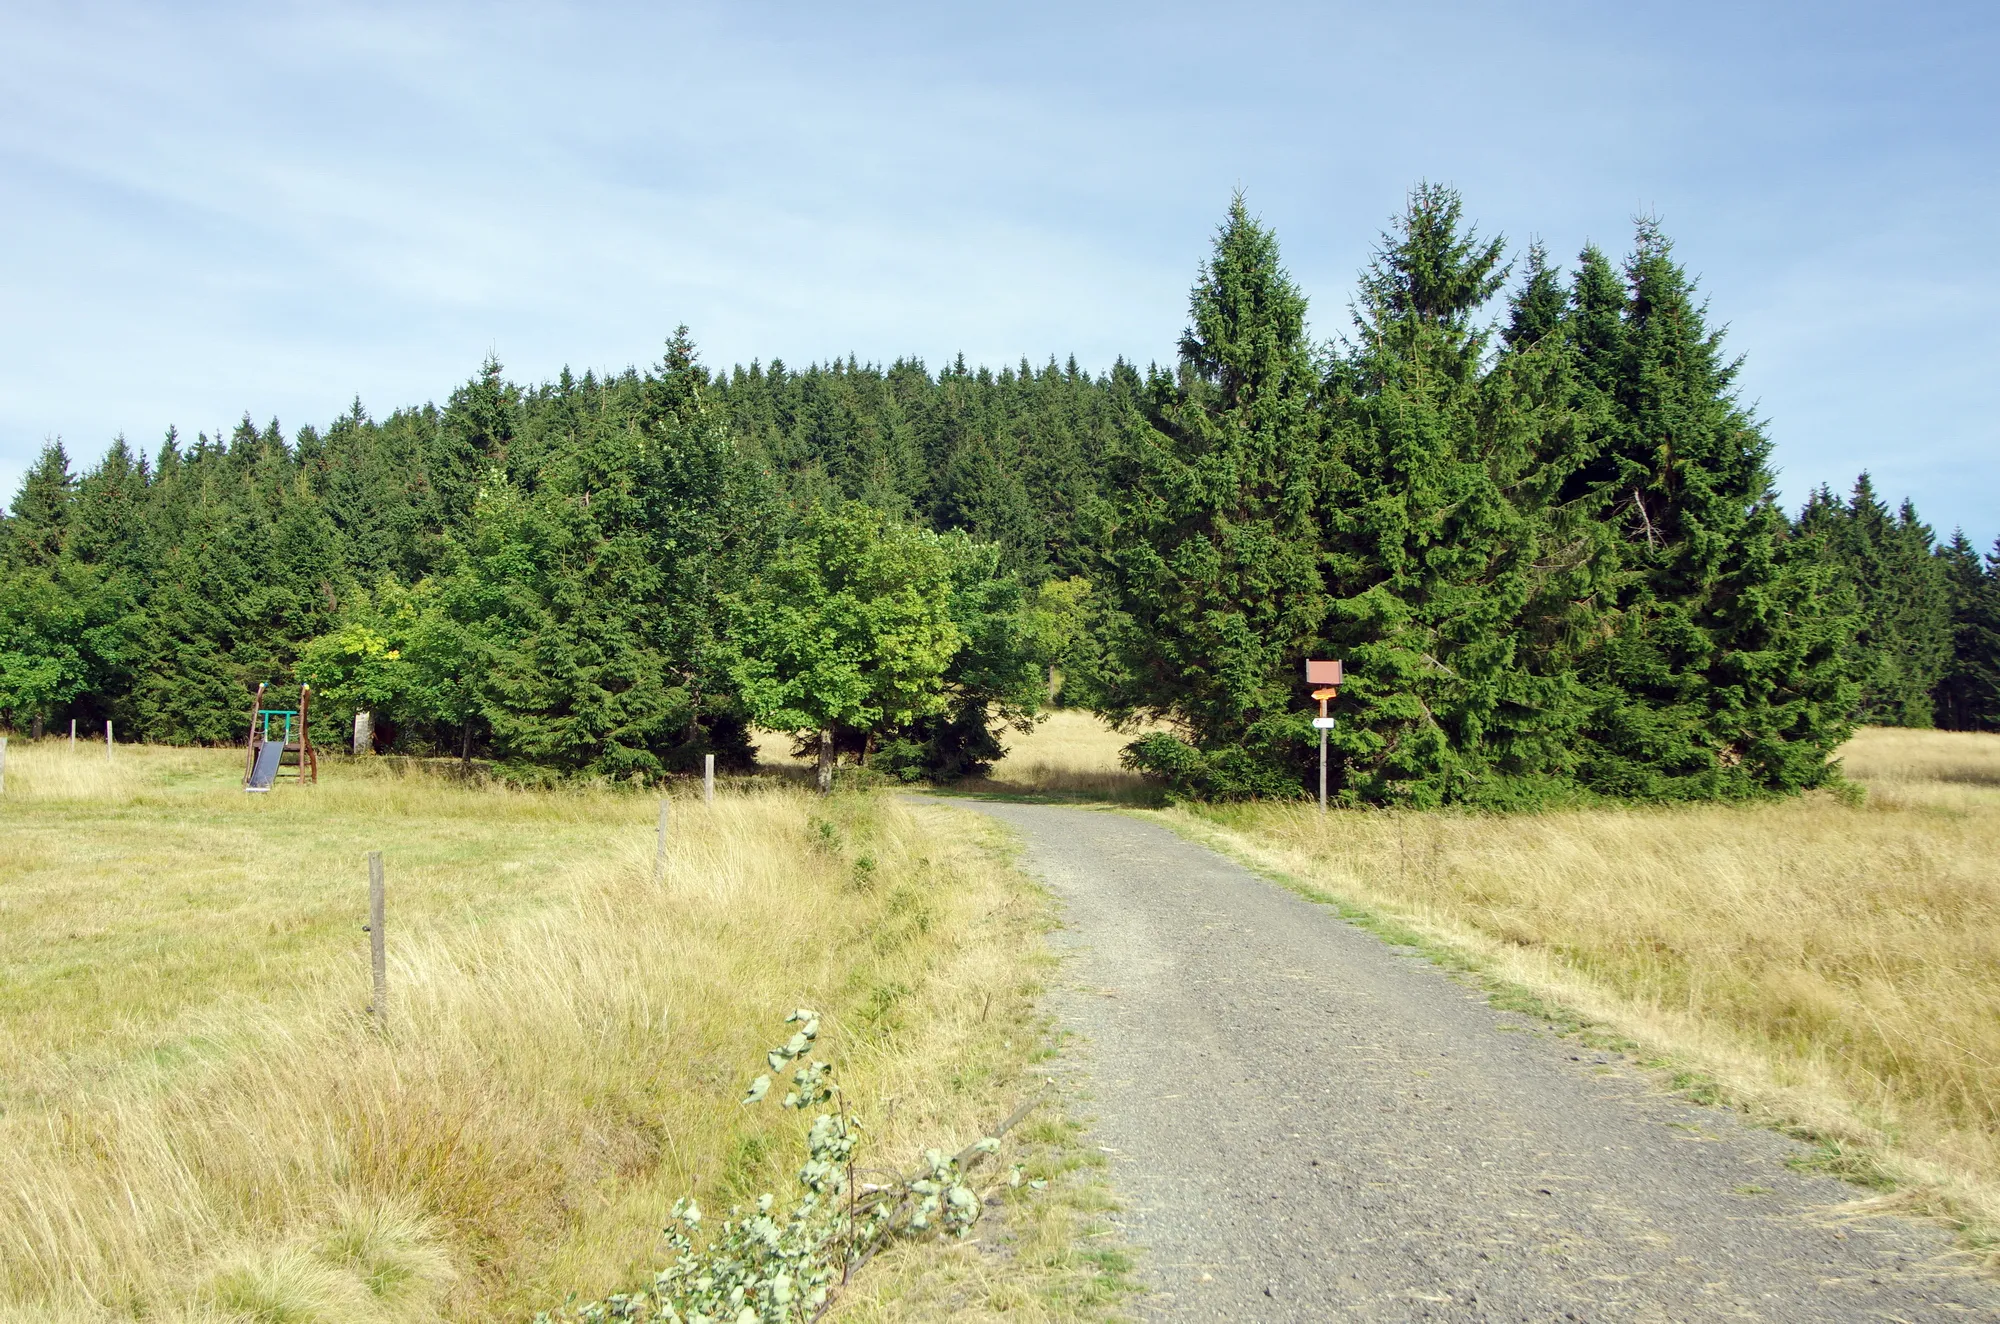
[940,802,2000,1322]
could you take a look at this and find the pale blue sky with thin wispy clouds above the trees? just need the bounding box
[0,2,2000,544]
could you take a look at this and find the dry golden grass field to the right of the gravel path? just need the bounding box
[1158,732,2000,1262]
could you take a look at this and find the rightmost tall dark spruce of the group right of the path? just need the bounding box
[1576,222,1852,798]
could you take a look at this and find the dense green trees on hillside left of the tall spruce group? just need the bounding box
[0,332,1112,778]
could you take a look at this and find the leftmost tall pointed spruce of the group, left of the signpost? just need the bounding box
[1108,196,1328,794]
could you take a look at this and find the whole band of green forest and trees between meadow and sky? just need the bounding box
[11,186,2000,804]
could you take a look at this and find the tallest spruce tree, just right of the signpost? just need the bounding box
[1320,184,1602,804]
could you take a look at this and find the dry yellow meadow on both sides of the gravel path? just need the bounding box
[0,712,2000,1324]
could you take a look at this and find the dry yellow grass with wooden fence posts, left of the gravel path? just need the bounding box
[0,742,1120,1324]
